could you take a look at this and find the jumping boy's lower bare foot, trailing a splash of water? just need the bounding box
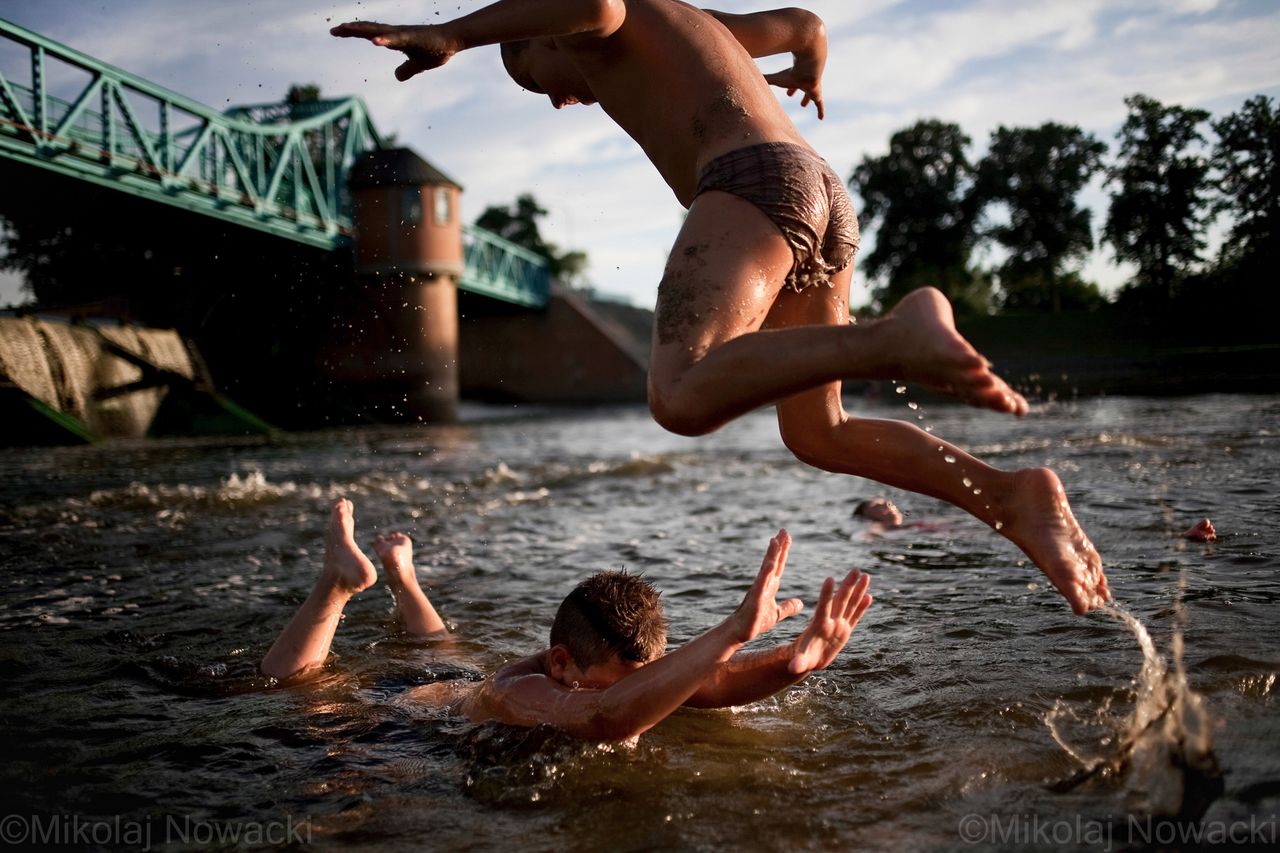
[996,467,1111,613]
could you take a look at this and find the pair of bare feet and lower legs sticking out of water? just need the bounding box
[259,498,445,679]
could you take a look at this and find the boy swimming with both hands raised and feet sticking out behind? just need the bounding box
[260,500,872,740]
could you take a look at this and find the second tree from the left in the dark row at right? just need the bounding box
[974,122,1107,313]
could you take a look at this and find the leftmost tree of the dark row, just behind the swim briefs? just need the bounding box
[849,119,989,313]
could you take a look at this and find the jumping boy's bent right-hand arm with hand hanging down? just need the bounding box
[705,8,827,119]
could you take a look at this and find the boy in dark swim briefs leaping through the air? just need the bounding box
[332,0,1110,613]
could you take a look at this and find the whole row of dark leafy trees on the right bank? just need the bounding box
[849,95,1280,314]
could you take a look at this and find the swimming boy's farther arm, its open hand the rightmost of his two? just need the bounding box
[685,552,873,708]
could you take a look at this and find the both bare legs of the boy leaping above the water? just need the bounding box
[649,192,1108,612]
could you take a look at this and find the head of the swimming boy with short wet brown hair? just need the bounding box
[552,571,667,669]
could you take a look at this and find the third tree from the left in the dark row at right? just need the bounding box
[1103,95,1210,301]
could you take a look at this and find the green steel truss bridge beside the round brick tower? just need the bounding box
[0,18,550,307]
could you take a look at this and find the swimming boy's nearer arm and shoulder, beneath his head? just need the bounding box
[462,532,803,740]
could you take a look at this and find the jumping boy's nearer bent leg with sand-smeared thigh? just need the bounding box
[649,192,1027,434]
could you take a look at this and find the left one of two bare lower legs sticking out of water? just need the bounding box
[259,498,378,679]
